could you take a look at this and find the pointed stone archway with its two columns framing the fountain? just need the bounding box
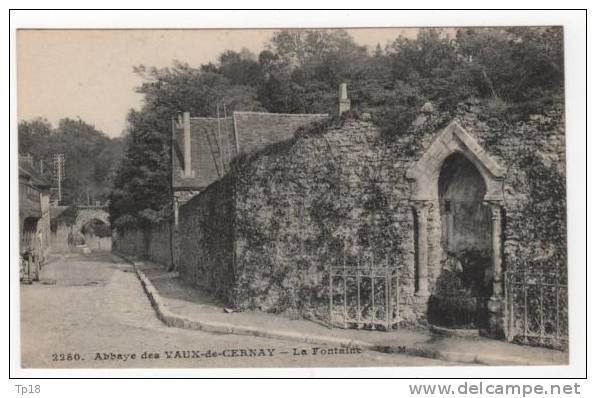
[406,121,505,334]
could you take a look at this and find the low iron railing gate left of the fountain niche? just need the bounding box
[329,261,399,331]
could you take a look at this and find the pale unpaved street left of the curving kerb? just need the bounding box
[21,253,448,368]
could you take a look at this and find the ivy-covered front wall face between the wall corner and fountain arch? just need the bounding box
[230,116,422,322]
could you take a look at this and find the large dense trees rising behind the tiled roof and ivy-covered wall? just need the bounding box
[111,27,564,224]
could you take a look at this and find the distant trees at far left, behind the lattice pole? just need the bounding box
[18,118,122,205]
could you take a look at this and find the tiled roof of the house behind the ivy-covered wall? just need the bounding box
[173,112,327,190]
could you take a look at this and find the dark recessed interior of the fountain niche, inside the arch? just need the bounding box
[428,152,492,329]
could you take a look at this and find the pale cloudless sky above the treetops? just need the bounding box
[17,28,418,137]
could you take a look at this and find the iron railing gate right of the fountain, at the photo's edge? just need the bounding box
[505,268,568,349]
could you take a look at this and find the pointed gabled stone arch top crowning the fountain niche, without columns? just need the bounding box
[406,121,505,201]
